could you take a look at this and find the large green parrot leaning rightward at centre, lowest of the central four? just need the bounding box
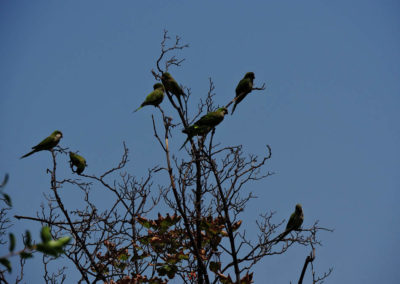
[179,107,228,150]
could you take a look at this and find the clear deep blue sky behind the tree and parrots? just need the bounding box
[0,0,400,283]
